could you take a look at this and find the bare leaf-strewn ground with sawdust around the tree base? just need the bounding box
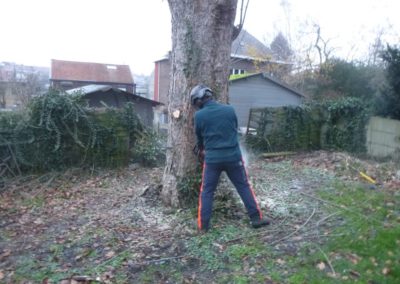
[0,152,400,283]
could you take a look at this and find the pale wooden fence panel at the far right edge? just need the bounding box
[366,116,400,157]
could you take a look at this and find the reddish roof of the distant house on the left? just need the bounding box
[50,59,134,84]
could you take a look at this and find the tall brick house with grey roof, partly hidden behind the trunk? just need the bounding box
[153,29,279,104]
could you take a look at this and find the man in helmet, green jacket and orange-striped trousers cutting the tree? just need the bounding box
[190,85,269,232]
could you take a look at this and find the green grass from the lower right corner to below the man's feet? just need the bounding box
[182,178,400,283]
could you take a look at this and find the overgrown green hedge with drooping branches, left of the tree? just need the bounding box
[0,90,159,175]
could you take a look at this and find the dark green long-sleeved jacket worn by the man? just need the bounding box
[194,100,242,163]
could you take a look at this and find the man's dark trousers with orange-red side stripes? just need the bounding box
[197,161,262,230]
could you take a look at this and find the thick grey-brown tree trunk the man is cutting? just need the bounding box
[162,0,237,206]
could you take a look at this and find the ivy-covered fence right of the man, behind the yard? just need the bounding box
[247,97,368,153]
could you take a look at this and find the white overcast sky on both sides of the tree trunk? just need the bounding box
[0,0,400,75]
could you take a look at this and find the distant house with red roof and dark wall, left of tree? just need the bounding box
[50,59,136,94]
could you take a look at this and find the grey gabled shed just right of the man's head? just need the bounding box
[229,73,305,127]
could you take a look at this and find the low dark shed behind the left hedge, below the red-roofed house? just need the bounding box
[66,85,161,127]
